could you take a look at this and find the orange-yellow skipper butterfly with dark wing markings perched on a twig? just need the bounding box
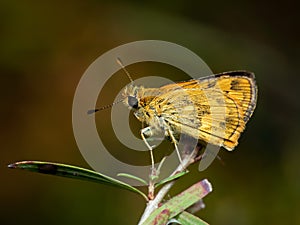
[123,71,257,167]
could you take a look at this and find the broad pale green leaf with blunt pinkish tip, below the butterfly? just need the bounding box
[143,179,212,225]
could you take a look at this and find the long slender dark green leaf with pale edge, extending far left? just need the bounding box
[8,161,148,201]
